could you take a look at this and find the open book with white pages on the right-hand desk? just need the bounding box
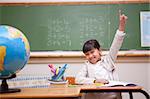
[103,81,137,87]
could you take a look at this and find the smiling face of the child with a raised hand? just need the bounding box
[85,48,101,64]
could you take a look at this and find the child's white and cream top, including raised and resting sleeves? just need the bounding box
[76,30,125,84]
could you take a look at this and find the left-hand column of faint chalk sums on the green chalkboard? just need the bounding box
[47,18,71,47]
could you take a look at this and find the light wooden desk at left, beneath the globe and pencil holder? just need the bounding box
[0,87,80,99]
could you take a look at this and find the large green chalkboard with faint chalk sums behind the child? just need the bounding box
[0,4,150,51]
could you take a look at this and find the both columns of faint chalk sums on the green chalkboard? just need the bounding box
[46,16,105,47]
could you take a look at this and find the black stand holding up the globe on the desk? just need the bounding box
[0,74,21,93]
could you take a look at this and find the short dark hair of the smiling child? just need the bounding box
[82,39,100,53]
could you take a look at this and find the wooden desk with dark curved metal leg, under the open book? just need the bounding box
[80,85,150,99]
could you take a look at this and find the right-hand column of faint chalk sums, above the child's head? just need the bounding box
[79,16,105,45]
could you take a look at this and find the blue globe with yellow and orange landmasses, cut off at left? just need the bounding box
[0,25,30,93]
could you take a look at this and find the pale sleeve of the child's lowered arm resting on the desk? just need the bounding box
[75,64,95,84]
